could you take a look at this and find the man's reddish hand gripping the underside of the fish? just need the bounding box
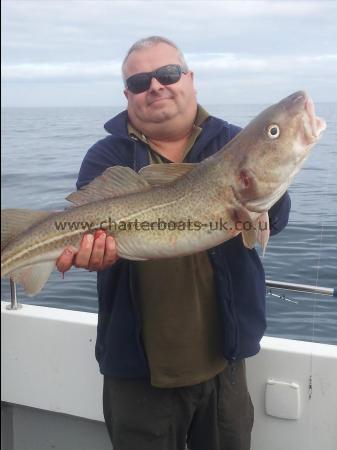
[56,230,118,273]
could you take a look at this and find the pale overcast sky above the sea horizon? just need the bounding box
[1,0,337,106]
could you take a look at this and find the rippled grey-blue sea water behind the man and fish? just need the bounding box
[1,103,337,344]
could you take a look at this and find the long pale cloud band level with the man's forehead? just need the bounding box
[1,53,337,82]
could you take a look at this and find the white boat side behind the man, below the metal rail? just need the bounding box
[1,302,337,450]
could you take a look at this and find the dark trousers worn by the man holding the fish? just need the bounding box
[103,361,254,450]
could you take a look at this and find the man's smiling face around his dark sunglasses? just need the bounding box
[124,43,196,131]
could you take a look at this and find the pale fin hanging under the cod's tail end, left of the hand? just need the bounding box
[9,261,55,297]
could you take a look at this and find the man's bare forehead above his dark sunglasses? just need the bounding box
[125,43,180,76]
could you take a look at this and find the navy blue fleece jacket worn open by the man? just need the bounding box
[77,111,290,378]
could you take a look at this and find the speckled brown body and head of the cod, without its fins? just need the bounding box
[1,91,325,294]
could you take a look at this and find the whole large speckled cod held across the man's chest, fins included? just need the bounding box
[1,91,326,295]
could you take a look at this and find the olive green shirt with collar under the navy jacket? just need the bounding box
[128,106,226,387]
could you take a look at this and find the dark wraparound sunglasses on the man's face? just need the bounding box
[125,64,187,94]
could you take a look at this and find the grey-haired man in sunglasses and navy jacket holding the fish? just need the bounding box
[58,37,290,450]
